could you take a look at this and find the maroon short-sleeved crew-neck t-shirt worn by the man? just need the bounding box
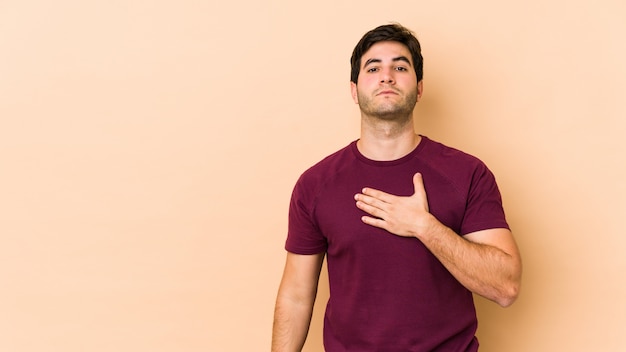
[285,136,508,352]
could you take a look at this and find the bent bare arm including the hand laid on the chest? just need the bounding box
[355,174,522,307]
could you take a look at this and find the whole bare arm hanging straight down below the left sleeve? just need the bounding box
[272,253,324,352]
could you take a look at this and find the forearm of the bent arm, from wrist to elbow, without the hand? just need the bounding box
[416,221,521,307]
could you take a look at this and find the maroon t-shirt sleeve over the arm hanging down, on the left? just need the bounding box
[285,177,328,254]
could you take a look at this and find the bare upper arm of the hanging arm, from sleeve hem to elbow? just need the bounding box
[279,252,325,300]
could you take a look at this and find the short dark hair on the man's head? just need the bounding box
[350,23,424,83]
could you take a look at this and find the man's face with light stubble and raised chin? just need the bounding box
[351,41,422,120]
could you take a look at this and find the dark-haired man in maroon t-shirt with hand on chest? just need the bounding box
[272,24,521,352]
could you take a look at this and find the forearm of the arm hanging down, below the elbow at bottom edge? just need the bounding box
[272,294,313,352]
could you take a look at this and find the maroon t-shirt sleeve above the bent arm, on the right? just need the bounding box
[461,163,509,235]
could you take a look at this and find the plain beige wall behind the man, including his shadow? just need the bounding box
[0,0,626,352]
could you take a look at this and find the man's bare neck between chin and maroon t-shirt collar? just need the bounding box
[357,117,421,161]
